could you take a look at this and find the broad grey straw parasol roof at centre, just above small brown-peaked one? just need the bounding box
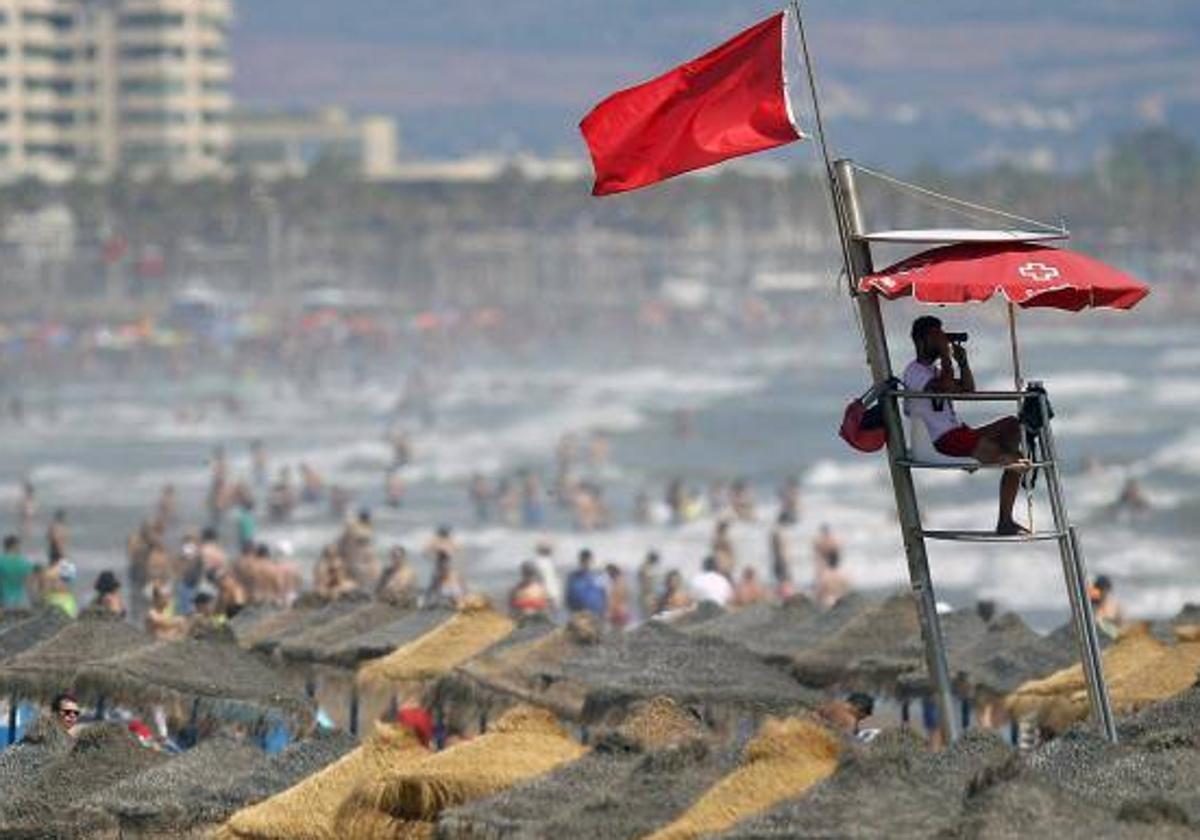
[563,622,820,722]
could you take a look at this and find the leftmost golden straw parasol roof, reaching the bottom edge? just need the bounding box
[217,725,428,840]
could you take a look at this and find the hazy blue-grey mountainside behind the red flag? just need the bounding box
[235,0,1200,167]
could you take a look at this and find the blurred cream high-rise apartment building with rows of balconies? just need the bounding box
[0,0,233,180]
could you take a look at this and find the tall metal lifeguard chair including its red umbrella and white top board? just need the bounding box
[830,160,1148,743]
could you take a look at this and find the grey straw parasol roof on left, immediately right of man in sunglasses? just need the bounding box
[69,638,314,730]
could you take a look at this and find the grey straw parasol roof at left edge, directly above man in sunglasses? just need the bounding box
[0,614,152,701]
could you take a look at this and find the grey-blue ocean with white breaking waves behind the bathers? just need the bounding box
[0,299,1200,628]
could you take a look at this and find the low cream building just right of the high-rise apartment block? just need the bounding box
[230,108,400,180]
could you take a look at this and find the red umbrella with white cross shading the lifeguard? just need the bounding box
[858,242,1150,312]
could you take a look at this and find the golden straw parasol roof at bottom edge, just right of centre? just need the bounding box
[647,718,842,840]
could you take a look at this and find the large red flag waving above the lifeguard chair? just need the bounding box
[580,12,802,196]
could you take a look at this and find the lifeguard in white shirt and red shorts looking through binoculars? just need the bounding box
[904,316,1028,535]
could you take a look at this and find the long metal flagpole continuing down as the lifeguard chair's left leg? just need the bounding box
[791,0,959,745]
